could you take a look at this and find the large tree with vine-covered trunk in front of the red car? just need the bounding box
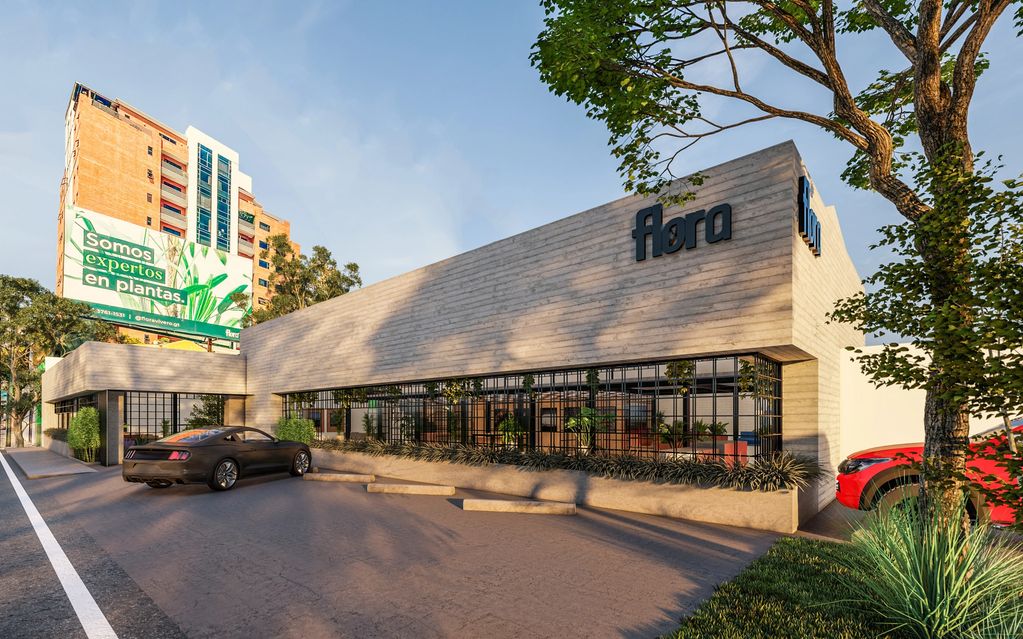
[531,0,1023,513]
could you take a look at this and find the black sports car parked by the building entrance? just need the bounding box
[121,426,312,491]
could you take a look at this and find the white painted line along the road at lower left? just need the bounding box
[0,454,118,639]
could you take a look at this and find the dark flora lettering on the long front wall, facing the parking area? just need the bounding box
[632,200,731,257]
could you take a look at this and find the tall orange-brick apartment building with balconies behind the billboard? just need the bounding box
[56,84,299,341]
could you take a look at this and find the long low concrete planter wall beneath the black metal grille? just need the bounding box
[312,449,799,533]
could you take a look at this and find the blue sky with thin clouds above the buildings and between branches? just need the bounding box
[0,0,1023,286]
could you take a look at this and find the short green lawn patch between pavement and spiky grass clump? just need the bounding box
[667,538,896,639]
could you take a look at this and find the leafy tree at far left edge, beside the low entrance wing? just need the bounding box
[0,275,117,446]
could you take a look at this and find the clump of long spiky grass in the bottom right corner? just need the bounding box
[843,506,1023,639]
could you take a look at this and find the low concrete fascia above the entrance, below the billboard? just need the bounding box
[43,341,246,402]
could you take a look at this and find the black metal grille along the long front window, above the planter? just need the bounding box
[283,355,782,461]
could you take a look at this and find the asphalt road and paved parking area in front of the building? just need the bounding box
[0,455,776,638]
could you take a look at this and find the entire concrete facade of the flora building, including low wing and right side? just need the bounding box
[44,142,863,516]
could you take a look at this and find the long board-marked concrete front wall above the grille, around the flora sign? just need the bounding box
[241,142,814,426]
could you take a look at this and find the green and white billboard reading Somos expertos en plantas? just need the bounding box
[63,204,252,340]
